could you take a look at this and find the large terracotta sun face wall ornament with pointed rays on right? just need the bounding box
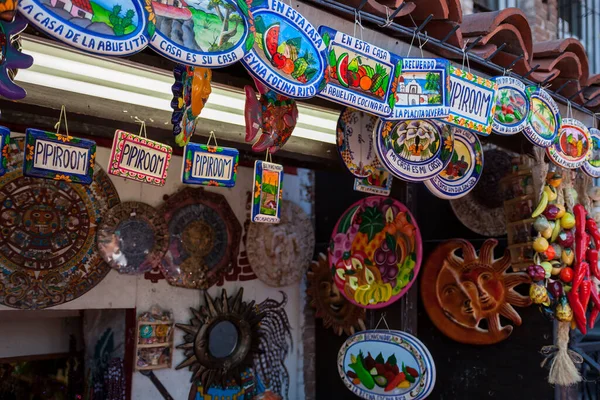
[421,239,531,345]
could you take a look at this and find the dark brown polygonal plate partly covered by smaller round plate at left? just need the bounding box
[159,188,242,289]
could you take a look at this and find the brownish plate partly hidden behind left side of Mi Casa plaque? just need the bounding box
[337,108,380,178]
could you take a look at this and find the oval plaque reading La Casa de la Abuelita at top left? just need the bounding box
[19,0,153,56]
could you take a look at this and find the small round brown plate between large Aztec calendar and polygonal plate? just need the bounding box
[98,201,169,274]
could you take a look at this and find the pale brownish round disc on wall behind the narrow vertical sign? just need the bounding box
[246,200,315,287]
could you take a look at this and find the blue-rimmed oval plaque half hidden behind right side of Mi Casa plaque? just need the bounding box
[425,128,483,200]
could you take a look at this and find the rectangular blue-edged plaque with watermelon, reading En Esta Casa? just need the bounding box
[319,26,398,117]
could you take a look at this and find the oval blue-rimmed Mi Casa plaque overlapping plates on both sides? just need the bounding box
[373,119,454,182]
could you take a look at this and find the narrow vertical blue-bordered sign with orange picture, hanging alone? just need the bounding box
[251,160,283,224]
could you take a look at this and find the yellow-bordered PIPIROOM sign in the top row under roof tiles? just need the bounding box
[446,65,498,136]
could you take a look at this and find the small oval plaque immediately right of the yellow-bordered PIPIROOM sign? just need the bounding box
[492,76,529,136]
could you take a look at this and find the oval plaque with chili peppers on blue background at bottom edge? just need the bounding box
[338,330,436,400]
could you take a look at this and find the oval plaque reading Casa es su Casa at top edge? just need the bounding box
[148,0,248,68]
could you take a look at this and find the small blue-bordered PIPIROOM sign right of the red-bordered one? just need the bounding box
[181,143,240,187]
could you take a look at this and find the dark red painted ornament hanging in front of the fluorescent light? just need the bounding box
[244,78,298,154]
